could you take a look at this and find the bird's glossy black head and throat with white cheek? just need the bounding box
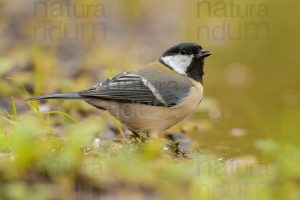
[159,43,211,82]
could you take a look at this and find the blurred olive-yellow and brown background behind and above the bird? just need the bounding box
[0,0,300,197]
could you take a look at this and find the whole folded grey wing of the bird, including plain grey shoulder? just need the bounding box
[78,68,192,107]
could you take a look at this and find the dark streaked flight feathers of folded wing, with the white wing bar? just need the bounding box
[78,72,190,107]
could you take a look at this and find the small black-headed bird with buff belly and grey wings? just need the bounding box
[25,43,211,138]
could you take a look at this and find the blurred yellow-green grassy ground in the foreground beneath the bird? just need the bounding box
[0,95,300,200]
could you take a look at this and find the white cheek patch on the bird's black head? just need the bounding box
[161,55,194,75]
